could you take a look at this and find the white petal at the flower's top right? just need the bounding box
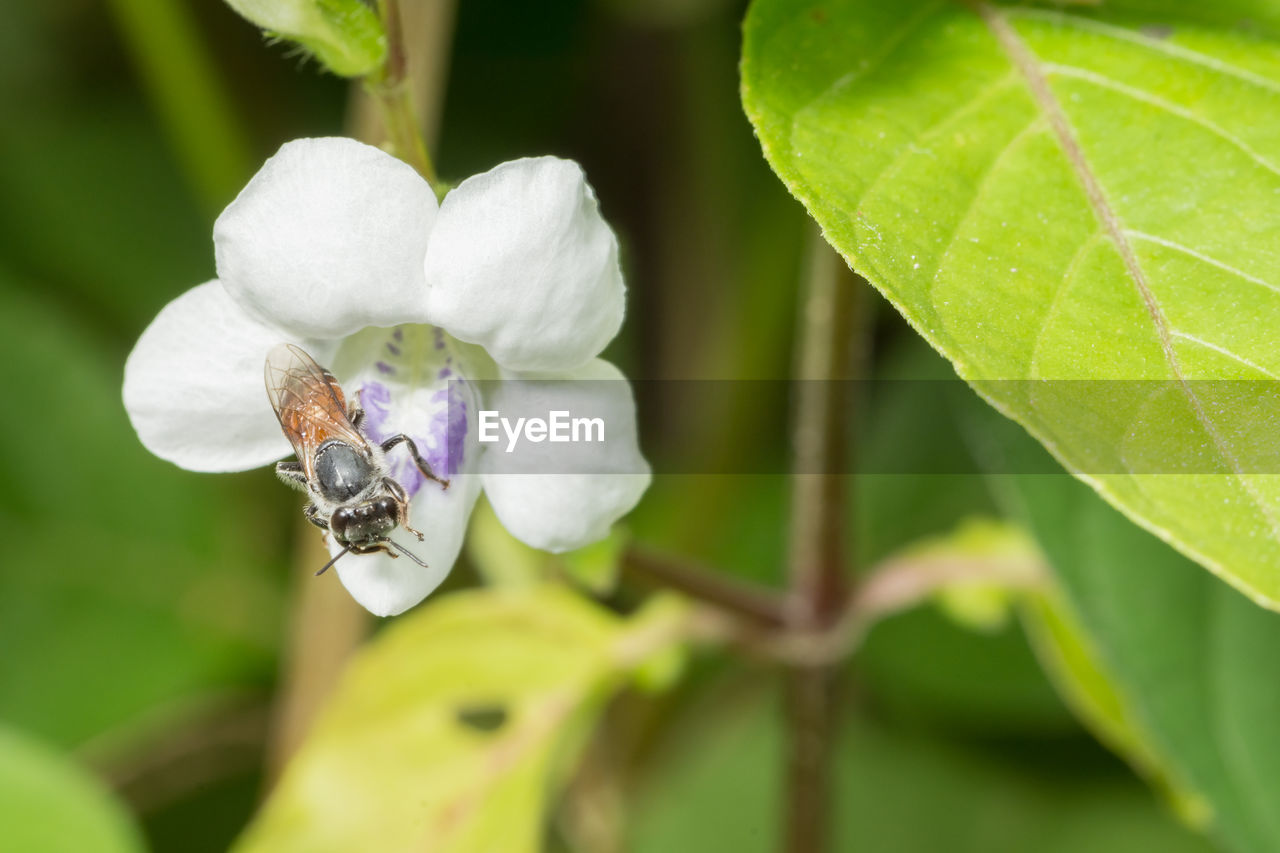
[426,158,625,370]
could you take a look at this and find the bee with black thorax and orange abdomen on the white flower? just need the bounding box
[265,343,449,575]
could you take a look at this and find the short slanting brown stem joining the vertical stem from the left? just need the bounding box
[622,547,786,628]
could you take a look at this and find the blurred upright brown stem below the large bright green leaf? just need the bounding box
[785,227,863,853]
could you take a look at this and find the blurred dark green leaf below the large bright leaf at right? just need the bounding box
[984,415,1280,850]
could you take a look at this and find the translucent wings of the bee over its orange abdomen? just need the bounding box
[264,343,369,479]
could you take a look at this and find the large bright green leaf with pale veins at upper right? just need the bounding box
[742,0,1280,607]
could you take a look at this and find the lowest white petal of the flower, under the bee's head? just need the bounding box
[329,474,480,616]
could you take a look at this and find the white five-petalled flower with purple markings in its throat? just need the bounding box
[124,138,649,615]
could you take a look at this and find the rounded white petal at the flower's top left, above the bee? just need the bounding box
[214,138,438,338]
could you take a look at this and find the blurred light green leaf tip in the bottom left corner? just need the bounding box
[0,727,145,853]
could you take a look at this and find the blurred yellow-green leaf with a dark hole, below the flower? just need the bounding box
[237,587,686,853]
